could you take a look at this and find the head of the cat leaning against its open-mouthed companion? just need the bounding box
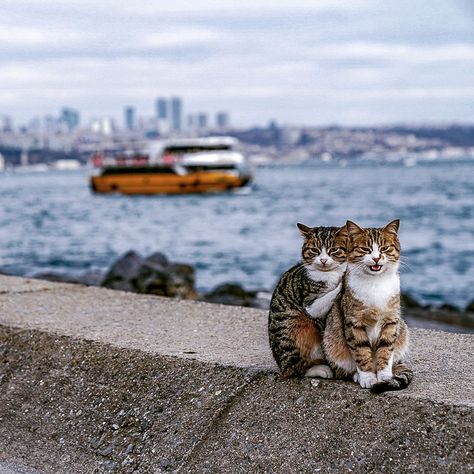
[297,224,347,272]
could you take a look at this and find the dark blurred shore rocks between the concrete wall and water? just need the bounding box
[0,250,474,334]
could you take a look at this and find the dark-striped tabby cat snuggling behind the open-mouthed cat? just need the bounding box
[268,224,347,378]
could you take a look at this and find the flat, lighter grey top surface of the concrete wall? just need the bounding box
[0,276,474,406]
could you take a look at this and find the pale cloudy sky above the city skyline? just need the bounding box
[0,0,474,127]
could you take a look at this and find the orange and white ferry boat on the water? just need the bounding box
[90,137,252,194]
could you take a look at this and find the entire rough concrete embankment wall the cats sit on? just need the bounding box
[0,276,474,474]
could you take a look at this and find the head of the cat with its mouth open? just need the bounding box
[346,219,400,275]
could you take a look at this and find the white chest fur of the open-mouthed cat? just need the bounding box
[347,267,400,309]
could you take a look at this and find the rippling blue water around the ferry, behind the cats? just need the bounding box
[0,157,474,307]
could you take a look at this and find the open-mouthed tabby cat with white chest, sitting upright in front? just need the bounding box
[323,220,413,392]
